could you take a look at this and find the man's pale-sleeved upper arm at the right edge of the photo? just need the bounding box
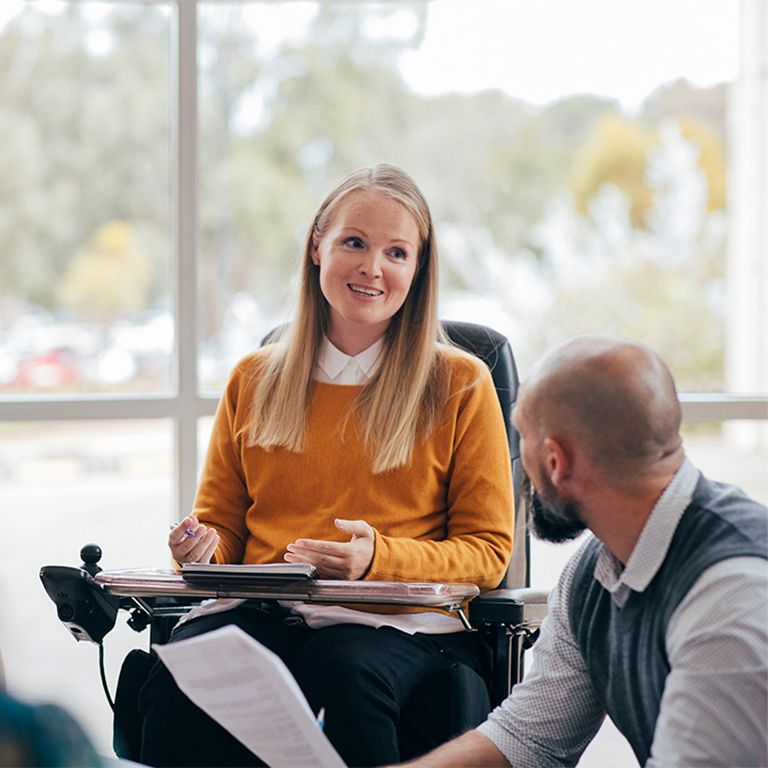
[646,558,768,768]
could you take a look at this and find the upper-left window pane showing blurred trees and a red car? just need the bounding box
[0,2,173,395]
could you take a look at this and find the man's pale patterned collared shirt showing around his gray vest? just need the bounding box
[478,459,768,768]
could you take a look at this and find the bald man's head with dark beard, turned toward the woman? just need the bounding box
[515,335,682,541]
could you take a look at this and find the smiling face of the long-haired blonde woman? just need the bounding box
[311,190,421,355]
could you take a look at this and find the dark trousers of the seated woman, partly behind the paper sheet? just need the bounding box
[139,603,490,768]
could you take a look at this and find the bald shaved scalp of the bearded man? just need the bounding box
[518,335,682,480]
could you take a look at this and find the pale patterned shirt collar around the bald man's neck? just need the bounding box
[595,457,700,607]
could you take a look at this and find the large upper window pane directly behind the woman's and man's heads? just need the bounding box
[198,2,760,392]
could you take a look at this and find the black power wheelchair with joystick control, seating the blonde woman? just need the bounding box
[40,322,546,760]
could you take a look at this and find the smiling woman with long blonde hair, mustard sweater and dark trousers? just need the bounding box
[141,165,513,766]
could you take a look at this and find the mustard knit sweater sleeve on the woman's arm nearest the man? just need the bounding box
[366,360,514,589]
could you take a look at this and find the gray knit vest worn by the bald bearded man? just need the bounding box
[568,477,768,765]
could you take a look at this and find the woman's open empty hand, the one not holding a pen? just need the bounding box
[284,520,375,581]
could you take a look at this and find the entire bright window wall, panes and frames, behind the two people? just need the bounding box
[0,0,768,750]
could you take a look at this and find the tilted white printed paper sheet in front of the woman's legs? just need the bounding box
[153,625,345,768]
